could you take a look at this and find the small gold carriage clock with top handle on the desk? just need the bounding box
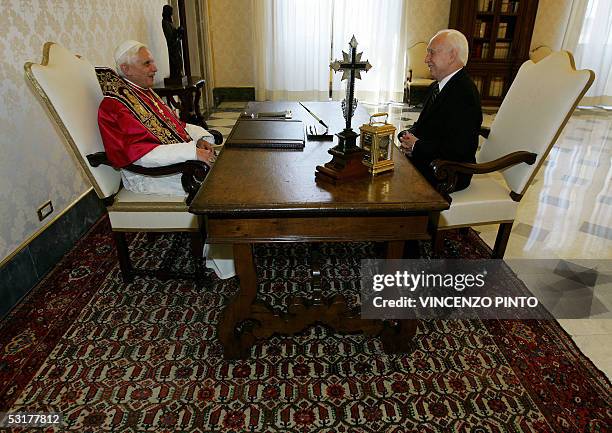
[359,113,395,175]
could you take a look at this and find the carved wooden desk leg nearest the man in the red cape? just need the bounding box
[218,244,257,359]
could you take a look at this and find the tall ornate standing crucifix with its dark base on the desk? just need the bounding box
[315,36,372,184]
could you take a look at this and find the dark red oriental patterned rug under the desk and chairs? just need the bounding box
[0,219,612,433]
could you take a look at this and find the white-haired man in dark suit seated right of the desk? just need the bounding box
[398,29,482,191]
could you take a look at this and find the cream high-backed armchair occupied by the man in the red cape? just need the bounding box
[24,42,208,282]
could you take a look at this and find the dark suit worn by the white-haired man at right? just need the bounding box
[402,68,482,191]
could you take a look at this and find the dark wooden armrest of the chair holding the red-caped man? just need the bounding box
[87,152,210,204]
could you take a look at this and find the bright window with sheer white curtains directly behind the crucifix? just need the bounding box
[254,0,406,102]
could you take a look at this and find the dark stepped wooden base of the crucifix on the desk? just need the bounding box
[315,129,370,185]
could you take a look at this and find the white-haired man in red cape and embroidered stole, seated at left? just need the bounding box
[98,41,215,195]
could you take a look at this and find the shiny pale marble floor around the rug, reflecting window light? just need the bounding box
[208,102,612,378]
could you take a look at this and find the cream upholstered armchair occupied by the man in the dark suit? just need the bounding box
[432,51,595,258]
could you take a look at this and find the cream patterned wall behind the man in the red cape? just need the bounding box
[0,0,168,260]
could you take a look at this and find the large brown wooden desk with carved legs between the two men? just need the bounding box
[190,102,449,359]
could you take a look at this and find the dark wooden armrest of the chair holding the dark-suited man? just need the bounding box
[431,151,537,196]
